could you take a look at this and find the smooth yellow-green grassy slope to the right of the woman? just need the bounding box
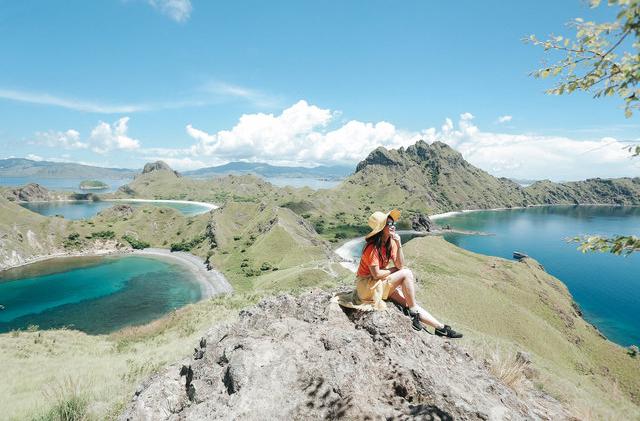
[405,237,640,419]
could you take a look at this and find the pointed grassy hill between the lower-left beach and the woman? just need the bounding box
[210,202,342,291]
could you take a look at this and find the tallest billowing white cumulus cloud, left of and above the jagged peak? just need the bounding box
[180,101,416,165]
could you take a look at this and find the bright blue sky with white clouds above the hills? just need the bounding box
[0,0,640,180]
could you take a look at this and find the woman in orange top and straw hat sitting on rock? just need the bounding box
[337,209,462,338]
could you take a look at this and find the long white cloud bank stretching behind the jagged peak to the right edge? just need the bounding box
[154,101,638,180]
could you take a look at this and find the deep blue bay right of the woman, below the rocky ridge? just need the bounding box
[437,206,640,346]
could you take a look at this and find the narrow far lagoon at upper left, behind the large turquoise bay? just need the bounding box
[20,200,209,219]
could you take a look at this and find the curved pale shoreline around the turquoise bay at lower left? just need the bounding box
[0,248,233,301]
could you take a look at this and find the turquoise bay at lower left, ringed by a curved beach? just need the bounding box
[0,256,201,334]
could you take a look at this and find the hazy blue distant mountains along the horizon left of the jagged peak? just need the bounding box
[0,158,353,180]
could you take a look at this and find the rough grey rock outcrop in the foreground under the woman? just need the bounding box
[120,292,568,420]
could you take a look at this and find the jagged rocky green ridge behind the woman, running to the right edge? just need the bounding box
[344,140,640,212]
